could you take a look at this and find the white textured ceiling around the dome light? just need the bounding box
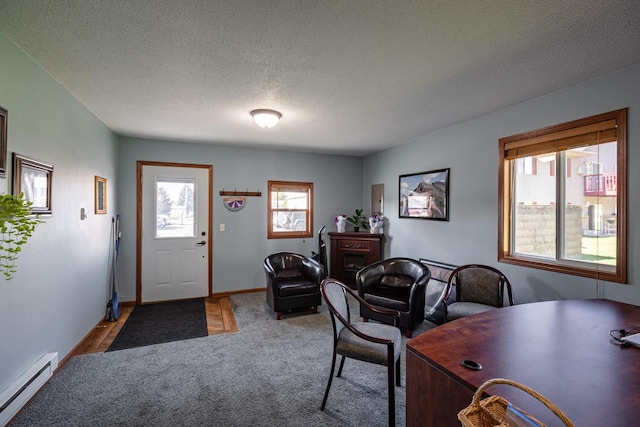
[0,0,640,155]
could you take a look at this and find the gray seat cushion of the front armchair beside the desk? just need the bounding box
[336,322,402,365]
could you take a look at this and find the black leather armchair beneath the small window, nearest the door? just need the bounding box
[264,252,324,320]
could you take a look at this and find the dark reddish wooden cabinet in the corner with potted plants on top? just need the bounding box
[329,232,384,289]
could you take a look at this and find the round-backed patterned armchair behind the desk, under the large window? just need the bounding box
[445,264,514,322]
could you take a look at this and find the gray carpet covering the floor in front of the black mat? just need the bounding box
[10,293,438,427]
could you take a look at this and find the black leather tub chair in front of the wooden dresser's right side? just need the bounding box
[356,258,431,338]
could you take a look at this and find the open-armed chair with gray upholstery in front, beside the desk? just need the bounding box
[320,278,402,426]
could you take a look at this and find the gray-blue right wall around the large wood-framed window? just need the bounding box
[363,64,640,305]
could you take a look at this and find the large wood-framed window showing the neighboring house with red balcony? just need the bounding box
[498,109,627,283]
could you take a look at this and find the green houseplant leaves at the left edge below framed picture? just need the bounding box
[0,193,43,280]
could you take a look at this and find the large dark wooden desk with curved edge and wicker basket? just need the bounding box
[406,300,640,426]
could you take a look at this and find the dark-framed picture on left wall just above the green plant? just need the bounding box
[13,153,53,214]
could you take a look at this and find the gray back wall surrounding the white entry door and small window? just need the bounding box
[118,138,363,301]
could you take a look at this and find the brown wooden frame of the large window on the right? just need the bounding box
[498,108,627,283]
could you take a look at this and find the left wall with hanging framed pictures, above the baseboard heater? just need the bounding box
[0,35,117,392]
